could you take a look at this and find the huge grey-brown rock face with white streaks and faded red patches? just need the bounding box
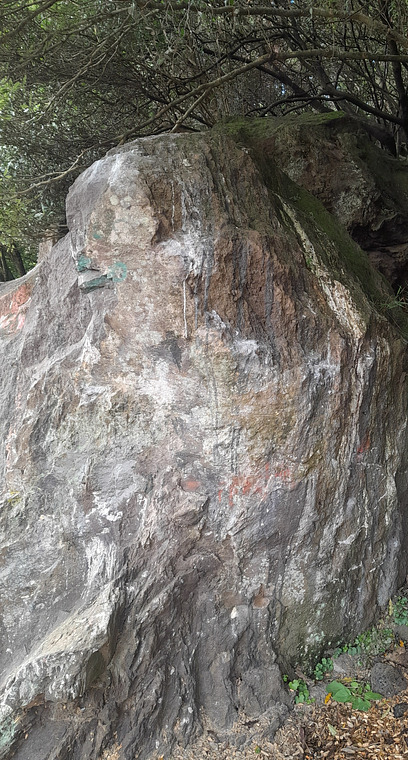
[0,120,408,760]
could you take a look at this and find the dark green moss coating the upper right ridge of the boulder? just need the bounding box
[214,112,408,339]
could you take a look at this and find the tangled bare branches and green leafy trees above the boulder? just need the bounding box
[0,0,408,279]
